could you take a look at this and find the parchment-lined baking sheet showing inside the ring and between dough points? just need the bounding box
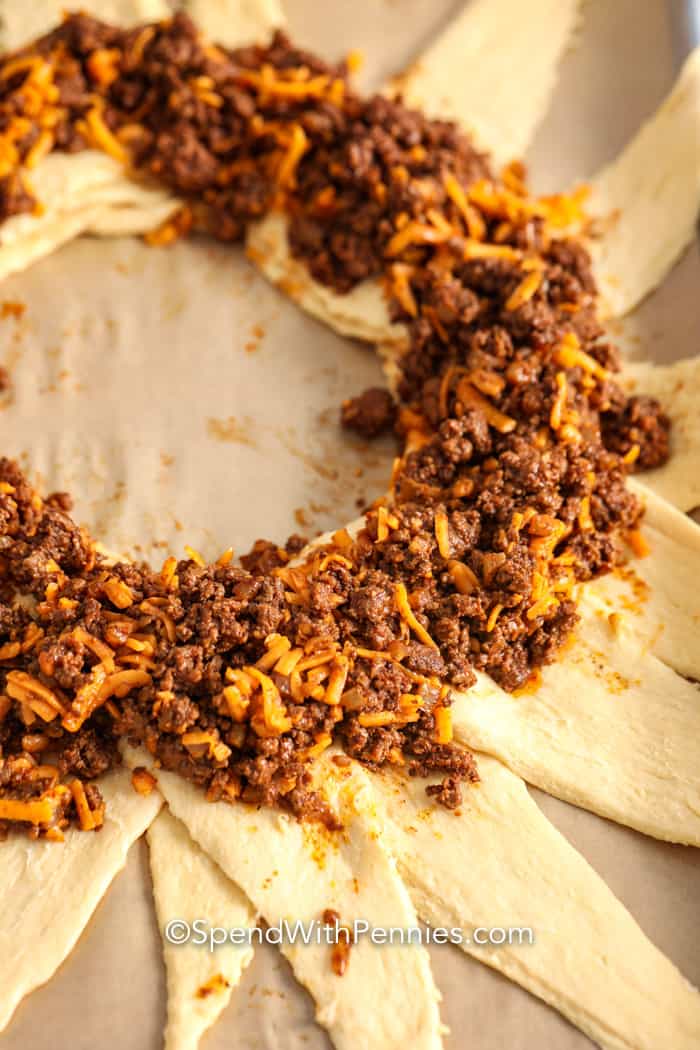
[0,0,700,1050]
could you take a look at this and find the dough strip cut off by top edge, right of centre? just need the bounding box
[393,0,581,167]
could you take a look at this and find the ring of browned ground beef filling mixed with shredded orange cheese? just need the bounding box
[0,15,669,838]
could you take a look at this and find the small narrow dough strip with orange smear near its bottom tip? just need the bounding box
[147,810,256,1050]
